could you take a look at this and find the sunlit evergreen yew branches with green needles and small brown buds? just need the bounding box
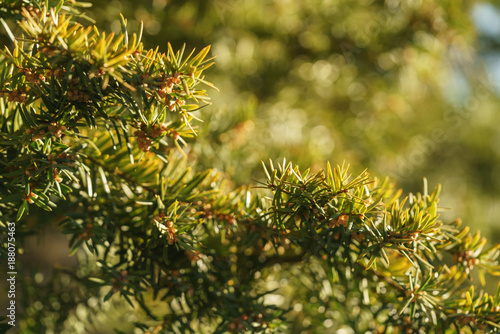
[0,0,500,333]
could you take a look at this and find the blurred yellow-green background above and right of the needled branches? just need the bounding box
[88,0,500,241]
